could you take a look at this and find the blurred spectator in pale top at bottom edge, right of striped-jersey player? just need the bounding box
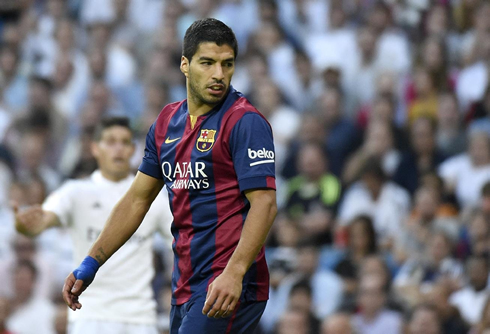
[353,276,403,334]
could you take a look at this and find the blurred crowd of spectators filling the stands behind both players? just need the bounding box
[0,0,490,334]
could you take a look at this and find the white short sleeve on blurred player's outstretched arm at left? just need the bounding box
[43,181,77,227]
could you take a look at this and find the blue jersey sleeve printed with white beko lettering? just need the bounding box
[230,112,276,192]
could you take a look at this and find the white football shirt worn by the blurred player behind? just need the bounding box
[43,171,172,333]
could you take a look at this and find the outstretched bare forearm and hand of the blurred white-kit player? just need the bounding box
[12,203,61,237]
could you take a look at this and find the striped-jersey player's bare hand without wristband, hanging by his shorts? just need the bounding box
[202,270,243,318]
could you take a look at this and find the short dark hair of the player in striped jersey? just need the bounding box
[182,18,238,62]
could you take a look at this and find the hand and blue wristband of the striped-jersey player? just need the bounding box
[62,256,100,311]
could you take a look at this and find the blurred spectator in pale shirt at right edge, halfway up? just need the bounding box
[439,132,490,208]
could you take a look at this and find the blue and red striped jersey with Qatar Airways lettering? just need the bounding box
[139,87,275,305]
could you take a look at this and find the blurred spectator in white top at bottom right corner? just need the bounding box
[449,256,489,326]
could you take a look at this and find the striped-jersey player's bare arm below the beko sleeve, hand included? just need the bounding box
[203,189,277,318]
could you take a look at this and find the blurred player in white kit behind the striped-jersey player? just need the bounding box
[14,117,172,334]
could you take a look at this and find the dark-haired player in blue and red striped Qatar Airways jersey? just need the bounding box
[63,19,277,334]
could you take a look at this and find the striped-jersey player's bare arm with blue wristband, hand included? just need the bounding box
[63,172,163,310]
